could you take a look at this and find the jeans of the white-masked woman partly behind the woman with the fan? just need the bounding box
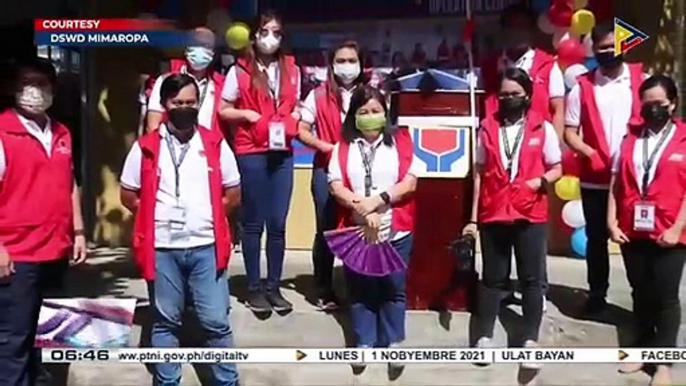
[311,168,336,296]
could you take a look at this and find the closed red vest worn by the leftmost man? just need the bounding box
[0,109,74,262]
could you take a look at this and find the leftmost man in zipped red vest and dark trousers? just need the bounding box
[0,59,86,386]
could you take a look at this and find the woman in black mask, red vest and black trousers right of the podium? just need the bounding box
[464,68,562,368]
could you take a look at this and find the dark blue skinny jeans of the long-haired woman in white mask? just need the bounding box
[237,152,293,291]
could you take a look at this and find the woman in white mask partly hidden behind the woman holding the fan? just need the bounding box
[298,41,366,311]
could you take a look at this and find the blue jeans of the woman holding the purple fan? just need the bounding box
[345,235,412,347]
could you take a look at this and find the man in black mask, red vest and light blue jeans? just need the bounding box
[121,74,240,386]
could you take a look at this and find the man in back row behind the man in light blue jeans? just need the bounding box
[146,27,224,135]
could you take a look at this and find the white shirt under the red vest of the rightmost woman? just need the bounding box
[612,122,676,190]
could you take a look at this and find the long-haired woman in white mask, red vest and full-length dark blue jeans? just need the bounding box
[220,13,300,313]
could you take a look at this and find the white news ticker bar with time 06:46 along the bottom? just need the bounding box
[42,348,686,364]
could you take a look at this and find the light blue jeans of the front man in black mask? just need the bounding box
[151,245,238,386]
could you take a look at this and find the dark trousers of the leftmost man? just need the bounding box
[0,259,68,386]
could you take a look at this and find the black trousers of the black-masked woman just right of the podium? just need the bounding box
[479,222,547,341]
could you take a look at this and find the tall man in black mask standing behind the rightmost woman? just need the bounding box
[565,21,645,313]
